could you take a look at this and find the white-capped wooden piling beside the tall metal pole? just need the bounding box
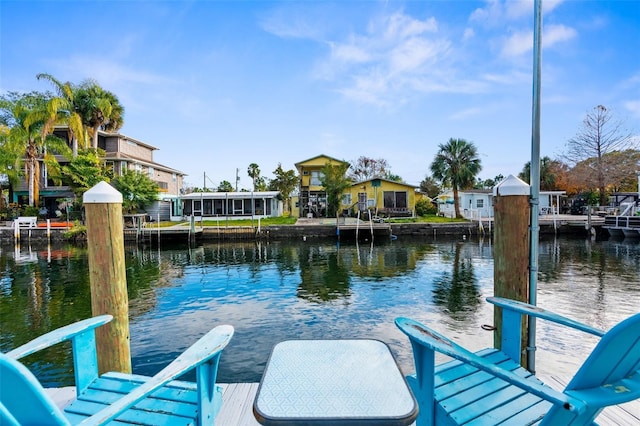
[493,175,530,366]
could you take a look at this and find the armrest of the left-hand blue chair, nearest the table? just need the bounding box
[80,325,233,425]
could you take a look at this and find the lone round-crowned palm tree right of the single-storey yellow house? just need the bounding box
[431,138,482,217]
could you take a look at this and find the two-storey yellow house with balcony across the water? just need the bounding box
[295,154,349,217]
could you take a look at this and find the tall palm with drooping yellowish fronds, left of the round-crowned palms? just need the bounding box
[36,73,86,158]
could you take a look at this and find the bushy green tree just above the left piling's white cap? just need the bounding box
[62,149,113,198]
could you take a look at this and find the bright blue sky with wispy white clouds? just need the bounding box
[0,0,640,188]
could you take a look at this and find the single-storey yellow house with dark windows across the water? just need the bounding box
[342,178,417,217]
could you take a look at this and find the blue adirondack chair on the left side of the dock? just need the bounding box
[0,315,233,425]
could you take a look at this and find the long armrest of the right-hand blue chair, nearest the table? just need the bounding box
[395,318,586,413]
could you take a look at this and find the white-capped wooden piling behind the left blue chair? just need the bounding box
[83,182,131,373]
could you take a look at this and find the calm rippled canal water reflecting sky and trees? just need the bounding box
[0,239,640,386]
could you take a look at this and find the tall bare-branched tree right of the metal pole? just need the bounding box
[564,105,634,205]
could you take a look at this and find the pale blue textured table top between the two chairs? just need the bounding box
[253,339,418,425]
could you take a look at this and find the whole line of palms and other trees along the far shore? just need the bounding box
[0,73,640,220]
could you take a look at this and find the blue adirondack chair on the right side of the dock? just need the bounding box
[395,297,640,426]
